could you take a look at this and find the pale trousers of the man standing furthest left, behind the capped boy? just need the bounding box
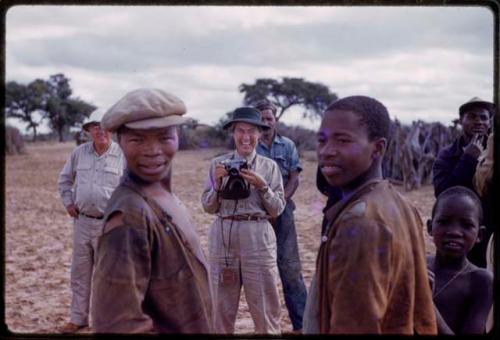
[70,216,102,325]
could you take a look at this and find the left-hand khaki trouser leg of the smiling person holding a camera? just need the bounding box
[208,223,241,334]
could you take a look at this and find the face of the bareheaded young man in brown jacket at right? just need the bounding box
[317,110,380,187]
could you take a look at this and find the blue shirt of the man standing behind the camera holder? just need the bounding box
[256,134,302,187]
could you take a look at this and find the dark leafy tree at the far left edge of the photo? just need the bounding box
[5,79,46,141]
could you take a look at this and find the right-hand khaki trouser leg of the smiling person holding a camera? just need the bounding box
[240,222,281,334]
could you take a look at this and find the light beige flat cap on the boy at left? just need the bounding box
[101,89,189,131]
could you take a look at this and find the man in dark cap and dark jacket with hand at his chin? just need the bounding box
[432,97,495,268]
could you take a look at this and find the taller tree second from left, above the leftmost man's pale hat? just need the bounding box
[45,74,96,142]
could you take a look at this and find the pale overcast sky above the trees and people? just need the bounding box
[5,5,494,132]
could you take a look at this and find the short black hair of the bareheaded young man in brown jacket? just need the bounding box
[325,96,391,141]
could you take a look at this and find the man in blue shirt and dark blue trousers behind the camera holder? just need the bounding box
[255,99,307,333]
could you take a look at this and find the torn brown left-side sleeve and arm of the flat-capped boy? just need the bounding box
[91,214,153,333]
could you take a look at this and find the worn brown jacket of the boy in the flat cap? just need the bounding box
[92,175,213,334]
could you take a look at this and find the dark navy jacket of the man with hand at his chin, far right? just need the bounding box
[432,143,478,197]
